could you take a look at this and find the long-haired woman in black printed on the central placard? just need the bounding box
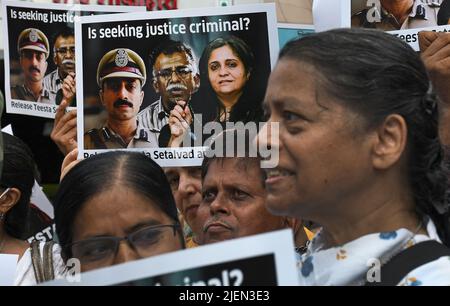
[200,36,263,122]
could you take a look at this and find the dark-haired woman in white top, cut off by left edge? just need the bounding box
[0,133,64,285]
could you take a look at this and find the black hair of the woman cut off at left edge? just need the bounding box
[1,132,37,240]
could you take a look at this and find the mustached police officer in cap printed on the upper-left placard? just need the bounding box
[11,28,55,104]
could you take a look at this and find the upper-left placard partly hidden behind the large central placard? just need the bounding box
[2,1,145,118]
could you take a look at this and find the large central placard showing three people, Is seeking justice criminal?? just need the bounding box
[75,4,278,167]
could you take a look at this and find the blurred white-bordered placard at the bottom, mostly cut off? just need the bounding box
[44,230,298,286]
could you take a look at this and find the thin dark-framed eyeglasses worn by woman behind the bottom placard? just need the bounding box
[65,223,181,264]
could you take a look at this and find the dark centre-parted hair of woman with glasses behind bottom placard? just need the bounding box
[53,151,184,258]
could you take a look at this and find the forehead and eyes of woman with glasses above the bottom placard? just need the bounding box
[71,187,182,271]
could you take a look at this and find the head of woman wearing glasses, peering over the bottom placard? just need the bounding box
[54,151,184,272]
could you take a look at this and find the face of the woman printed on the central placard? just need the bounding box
[208,46,249,96]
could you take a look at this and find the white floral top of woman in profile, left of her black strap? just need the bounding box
[298,219,440,285]
